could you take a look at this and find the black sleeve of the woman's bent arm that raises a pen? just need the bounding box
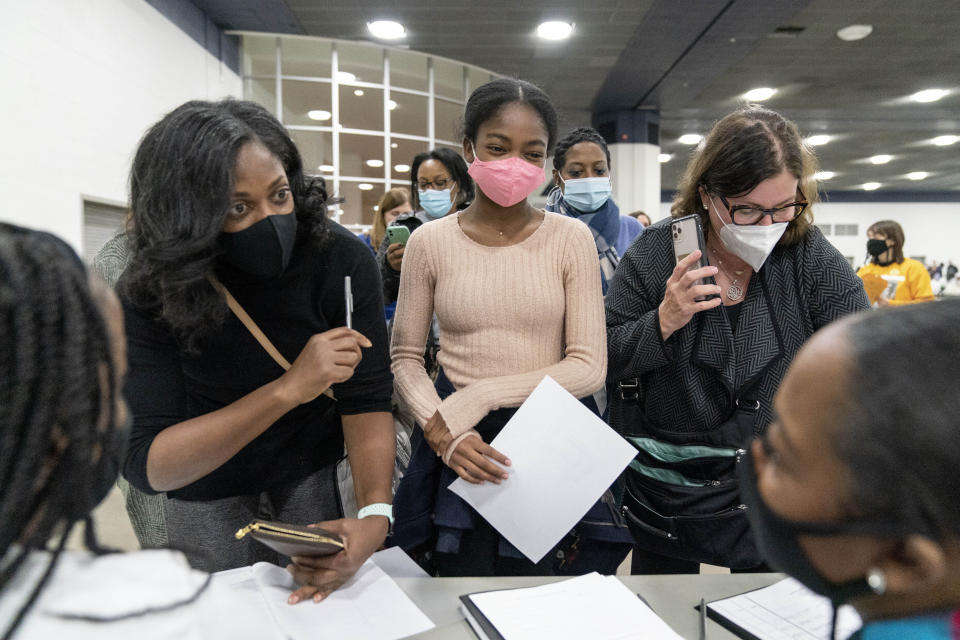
[122,299,187,493]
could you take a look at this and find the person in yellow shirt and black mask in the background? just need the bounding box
[857,220,933,307]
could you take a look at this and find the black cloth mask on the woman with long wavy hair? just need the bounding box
[218,213,297,280]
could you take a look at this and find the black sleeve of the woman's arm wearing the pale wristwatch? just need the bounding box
[333,239,393,415]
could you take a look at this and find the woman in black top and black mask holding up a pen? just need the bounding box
[119,100,395,603]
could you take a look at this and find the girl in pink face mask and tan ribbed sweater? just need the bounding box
[391,79,606,575]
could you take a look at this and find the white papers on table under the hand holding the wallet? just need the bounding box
[214,560,434,640]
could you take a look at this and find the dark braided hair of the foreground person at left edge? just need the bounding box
[0,223,123,638]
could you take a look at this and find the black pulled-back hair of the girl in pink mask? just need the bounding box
[463,78,558,154]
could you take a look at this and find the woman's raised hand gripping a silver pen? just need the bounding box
[280,327,373,405]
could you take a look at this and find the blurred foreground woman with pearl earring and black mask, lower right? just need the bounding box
[741,300,960,640]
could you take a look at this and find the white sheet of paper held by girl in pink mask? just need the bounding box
[450,376,637,562]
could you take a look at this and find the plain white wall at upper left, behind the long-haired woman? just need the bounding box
[0,0,242,250]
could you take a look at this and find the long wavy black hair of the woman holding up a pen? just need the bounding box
[121,99,329,352]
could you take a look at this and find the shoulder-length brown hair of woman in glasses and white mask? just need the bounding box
[670,105,818,246]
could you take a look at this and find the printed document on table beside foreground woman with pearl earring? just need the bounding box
[707,578,861,640]
